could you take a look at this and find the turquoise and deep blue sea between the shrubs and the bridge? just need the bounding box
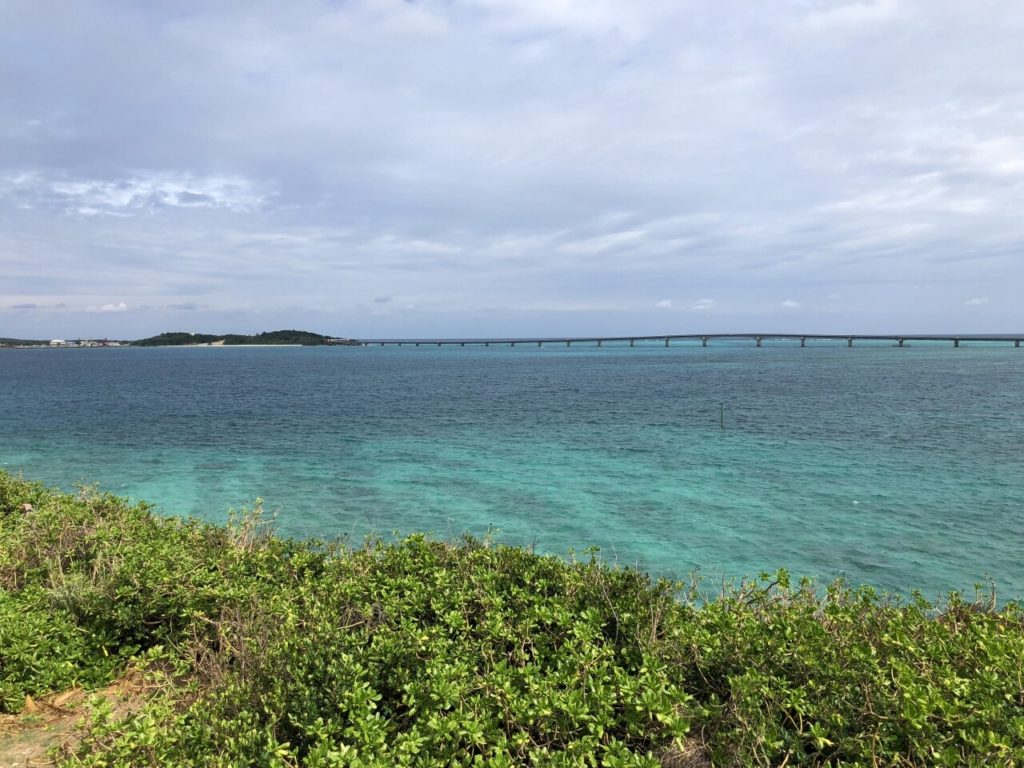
[0,342,1024,597]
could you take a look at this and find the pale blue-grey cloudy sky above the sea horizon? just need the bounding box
[0,0,1024,339]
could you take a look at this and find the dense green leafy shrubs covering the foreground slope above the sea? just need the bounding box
[0,473,1024,767]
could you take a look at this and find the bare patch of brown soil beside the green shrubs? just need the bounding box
[0,673,145,768]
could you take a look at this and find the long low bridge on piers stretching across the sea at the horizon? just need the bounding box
[331,333,1024,347]
